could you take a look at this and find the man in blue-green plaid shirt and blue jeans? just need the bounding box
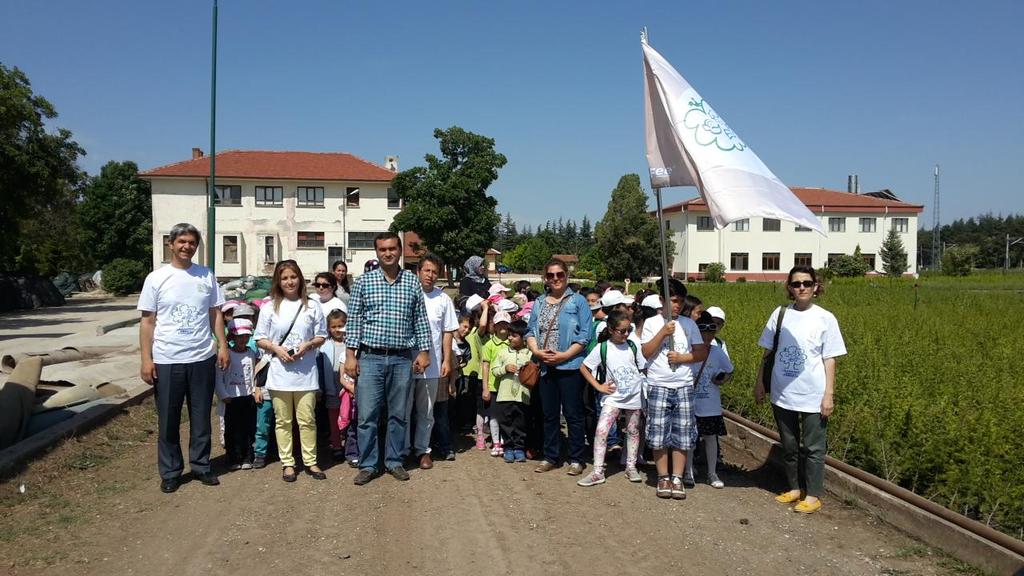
[345,232,430,486]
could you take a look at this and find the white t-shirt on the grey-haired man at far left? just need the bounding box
[137,263,224,364]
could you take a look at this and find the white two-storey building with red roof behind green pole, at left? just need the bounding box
[139,149,401,278]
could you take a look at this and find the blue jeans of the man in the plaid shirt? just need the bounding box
[355,352,413,471]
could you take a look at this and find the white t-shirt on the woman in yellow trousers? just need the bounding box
[253,298,327,392]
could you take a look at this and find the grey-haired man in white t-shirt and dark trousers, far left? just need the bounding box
[138,223,230,493]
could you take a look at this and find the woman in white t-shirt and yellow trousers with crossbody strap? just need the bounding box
[255,260,327,482]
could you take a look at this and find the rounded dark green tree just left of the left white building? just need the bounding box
[78,162,153,269]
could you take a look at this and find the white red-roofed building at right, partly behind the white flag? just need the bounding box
[663,188,924,281]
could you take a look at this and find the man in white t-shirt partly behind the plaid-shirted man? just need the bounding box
[406,253,459,470]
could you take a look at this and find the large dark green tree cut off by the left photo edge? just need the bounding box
[0,64,85,275]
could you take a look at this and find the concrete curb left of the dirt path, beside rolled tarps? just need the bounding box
[0,377,154,477]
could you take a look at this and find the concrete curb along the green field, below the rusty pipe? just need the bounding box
[721,418,1024,576]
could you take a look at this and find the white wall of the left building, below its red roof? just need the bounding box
[148,177,398,279]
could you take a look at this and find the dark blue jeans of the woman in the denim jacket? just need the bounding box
[538,368,587,464]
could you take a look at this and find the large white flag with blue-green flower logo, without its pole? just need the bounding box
[641,42,824,235]
